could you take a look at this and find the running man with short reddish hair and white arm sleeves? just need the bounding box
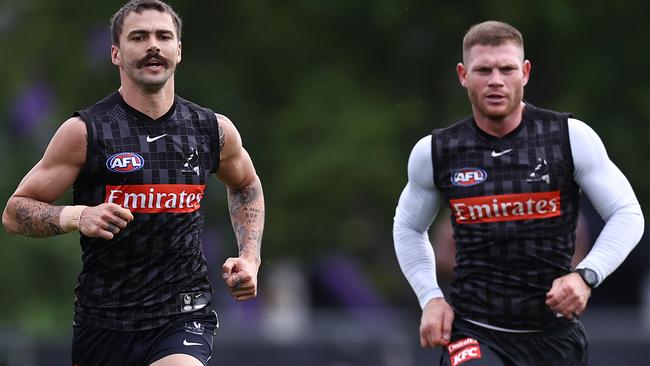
[393,21,644,366]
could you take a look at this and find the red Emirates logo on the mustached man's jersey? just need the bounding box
[104,184,205,213]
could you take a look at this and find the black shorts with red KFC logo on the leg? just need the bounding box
[440,319,588,366]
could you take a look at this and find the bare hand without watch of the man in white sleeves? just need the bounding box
[420,297,454,348]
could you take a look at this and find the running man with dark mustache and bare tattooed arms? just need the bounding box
[2,0,264,366]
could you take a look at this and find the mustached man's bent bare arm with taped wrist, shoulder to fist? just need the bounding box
[2,118,133,239]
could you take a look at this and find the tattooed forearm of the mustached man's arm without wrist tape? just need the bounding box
[228,180,264,259]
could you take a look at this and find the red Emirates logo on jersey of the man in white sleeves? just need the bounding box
[449,191,562,224]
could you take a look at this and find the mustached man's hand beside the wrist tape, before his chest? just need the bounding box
[79,203,133,240]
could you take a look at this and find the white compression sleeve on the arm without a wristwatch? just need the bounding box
[393,136,443,308]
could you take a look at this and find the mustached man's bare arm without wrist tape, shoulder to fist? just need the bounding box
[217,115,264,301]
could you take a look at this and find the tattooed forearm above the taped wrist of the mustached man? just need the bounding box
[14,197,65,238]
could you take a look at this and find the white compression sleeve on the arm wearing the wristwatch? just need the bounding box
[569,118,644,284]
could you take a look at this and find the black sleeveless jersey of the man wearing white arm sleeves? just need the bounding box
[432,104,579,329]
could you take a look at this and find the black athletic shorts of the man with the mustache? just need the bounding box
[72,311,219,366]
